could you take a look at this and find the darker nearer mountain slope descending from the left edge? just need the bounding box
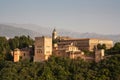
[0,24,41,38]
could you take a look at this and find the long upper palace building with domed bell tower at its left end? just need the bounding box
[52,29,113,51]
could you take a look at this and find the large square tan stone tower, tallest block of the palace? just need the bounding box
[34,36,52,62]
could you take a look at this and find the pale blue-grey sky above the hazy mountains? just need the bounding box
[0,0,120,34]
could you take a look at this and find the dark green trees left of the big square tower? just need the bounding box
[0,36,33,60]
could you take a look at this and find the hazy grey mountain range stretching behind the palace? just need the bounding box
[0,24,120,42]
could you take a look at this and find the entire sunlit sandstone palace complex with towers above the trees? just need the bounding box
[11,29,113,62]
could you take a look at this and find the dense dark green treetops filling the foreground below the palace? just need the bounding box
[0,55,120,80]
